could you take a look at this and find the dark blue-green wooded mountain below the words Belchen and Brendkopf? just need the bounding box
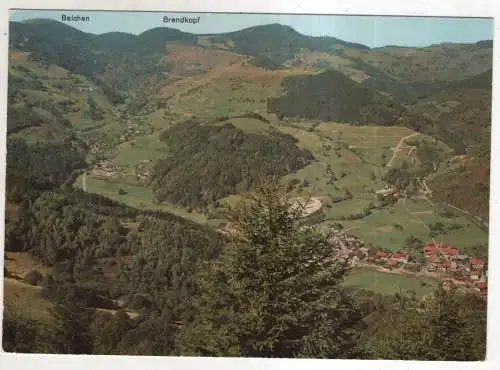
[10,19,190,97]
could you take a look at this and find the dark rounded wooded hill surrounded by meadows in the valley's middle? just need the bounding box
[151,121,314,208]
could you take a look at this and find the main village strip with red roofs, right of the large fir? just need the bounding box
[324,230,488,294]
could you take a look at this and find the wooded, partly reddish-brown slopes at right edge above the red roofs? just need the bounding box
[415,70,492,220]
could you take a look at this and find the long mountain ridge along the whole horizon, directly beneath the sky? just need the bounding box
[10,20,492,100]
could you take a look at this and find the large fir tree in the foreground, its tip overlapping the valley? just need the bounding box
[177,180,361,358]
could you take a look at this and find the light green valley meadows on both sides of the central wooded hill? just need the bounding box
[70,115,488,294]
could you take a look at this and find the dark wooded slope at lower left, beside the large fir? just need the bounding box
[3,185,223,353]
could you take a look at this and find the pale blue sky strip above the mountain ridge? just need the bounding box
[11,10,493,47]
